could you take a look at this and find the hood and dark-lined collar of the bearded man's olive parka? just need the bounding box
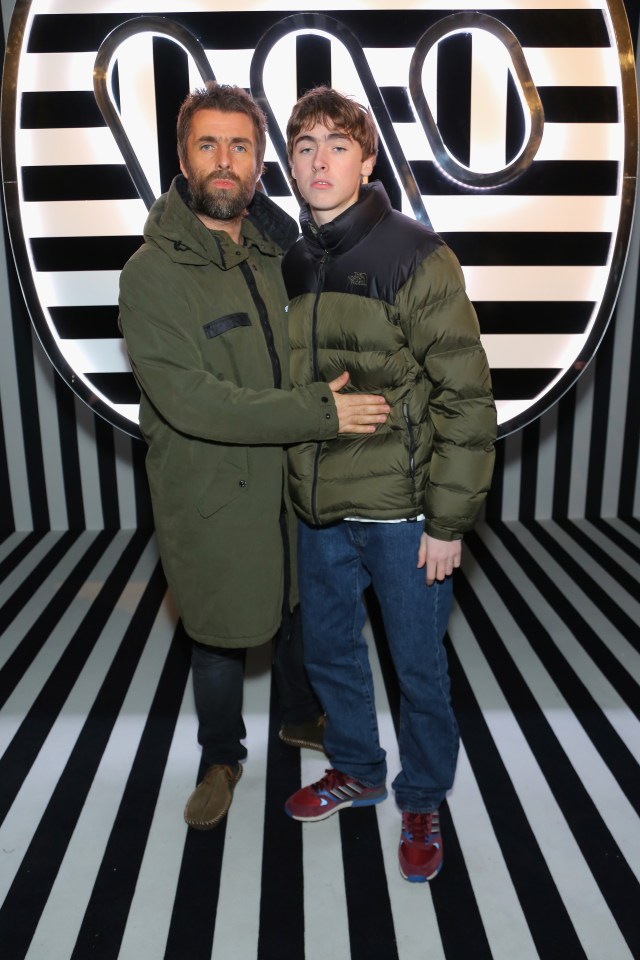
[144,174,298,270]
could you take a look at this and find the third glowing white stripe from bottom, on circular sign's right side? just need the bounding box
[464,267,609,301]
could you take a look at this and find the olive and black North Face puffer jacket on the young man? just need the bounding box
[283,183,496,540]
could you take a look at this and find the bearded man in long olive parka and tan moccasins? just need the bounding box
[120,83,388,830]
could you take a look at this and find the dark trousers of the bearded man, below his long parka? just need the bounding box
[191,514,322,769]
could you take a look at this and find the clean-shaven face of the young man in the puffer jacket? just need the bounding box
[290,123,375,225]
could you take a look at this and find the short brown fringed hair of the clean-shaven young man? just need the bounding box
[287,87,378,160]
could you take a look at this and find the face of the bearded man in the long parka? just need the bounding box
[180,110,260,221]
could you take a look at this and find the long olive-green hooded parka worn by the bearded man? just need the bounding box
[120,176,338,647]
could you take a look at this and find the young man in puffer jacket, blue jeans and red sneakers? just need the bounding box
[283,87,496,882]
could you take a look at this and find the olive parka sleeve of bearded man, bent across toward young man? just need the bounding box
[119,246,338,445]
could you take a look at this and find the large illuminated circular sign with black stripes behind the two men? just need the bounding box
[2,0,638,436]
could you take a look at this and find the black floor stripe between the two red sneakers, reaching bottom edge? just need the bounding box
[338,801,400,960]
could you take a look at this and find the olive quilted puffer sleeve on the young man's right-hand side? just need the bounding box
[400,245,497,540]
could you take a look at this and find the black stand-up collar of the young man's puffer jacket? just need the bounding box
[300,180,392,255]
